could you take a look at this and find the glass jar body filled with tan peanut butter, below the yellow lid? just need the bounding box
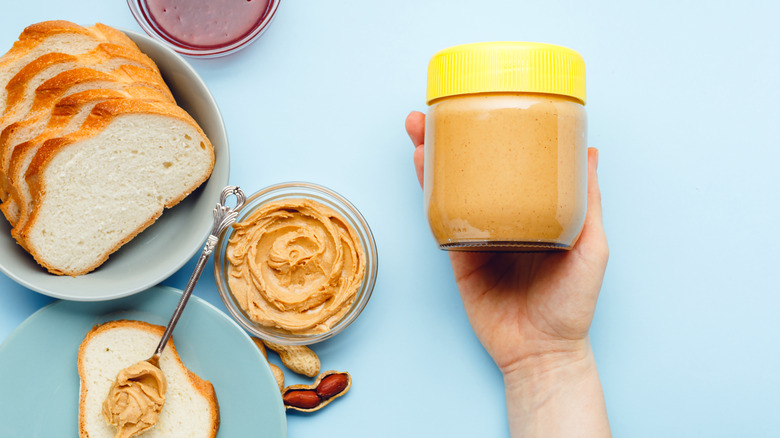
[424,93,587,249]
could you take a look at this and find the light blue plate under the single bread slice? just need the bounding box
[0,286,287,437]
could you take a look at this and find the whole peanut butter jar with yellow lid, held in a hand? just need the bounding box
[424,42,587,251]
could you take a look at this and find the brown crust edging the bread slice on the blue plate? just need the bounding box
[76,319,220,438]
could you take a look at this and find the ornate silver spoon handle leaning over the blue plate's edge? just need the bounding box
[150,186,246,363]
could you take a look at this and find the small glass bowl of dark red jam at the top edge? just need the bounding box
[127,0,281,58]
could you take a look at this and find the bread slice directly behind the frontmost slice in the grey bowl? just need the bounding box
[0,85,174,229]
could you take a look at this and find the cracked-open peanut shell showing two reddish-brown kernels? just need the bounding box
[282,370,352,412]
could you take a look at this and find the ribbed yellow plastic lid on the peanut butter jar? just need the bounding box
[426,41,585,105]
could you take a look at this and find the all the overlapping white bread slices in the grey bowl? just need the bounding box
[0,21,215,276]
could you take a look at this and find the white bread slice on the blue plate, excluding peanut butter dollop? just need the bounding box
[77,320,220,438]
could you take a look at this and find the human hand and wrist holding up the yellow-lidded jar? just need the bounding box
[406,112,611,438]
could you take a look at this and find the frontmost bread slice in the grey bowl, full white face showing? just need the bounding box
[17,99,214,276]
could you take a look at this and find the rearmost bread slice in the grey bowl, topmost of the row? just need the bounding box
[0,20,138,113]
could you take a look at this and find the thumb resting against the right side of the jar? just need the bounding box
[575,148,609,265]
